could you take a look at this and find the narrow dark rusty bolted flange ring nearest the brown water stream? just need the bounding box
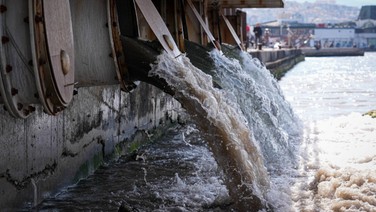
[107,0,136,92]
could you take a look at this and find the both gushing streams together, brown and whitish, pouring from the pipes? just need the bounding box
[150,51,298,210]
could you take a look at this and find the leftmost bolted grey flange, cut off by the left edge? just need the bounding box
[0,0,39,118]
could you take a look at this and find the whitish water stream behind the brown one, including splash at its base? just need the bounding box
[210,51,303,211]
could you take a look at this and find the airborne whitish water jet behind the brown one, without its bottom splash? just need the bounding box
[210,51,302,167]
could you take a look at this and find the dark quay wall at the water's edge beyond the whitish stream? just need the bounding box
[250,49,305,79]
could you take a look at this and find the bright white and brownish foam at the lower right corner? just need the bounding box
[292,113,376,211]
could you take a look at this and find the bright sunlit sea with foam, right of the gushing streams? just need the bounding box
[279,53,376,211]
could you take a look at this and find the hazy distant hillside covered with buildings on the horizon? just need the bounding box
[243,1,360,25]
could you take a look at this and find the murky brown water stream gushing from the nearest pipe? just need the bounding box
[152,51,274,207]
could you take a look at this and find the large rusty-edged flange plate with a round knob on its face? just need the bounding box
[29,0,75,115]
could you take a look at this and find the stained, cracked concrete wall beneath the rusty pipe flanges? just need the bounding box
[0,83,180,211]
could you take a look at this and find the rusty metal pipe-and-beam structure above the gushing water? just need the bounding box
[0,0,284,118]
